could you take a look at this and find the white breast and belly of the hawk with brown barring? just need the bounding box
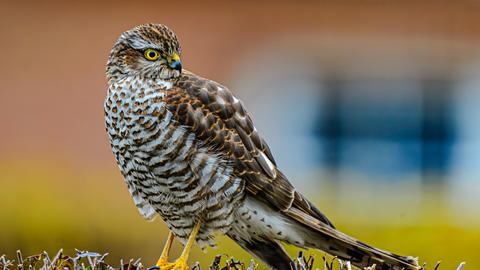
[105,79,244,247]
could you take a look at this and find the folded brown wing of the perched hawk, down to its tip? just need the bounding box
[165,72,332,226]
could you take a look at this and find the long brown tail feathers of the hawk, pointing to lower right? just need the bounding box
[285,207,420,270]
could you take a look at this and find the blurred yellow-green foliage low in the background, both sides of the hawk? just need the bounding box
[0,162,480,269]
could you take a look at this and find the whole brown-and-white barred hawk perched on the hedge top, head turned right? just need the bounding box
[104,24,419,270]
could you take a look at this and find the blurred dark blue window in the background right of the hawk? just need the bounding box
[314,78,455,181]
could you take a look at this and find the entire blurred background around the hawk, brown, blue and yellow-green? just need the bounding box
[0,0,480,269]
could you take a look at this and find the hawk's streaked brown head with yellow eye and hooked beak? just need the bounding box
[107,24,182,81]
